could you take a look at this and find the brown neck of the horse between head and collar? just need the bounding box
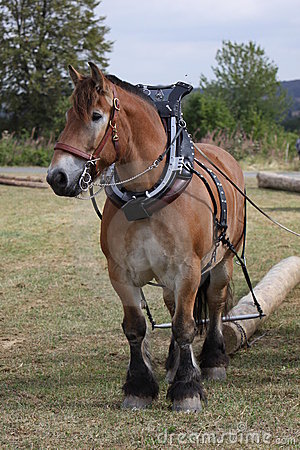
[116,91,167,191]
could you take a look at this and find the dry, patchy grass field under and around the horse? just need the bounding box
[0,175,300,449]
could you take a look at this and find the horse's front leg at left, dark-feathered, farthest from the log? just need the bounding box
[111,279,158,409]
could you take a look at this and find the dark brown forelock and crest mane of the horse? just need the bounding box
[72,75,155,122]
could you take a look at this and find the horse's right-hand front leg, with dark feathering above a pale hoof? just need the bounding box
[167,271,205,412]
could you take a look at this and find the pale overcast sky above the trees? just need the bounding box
[98,0,300,86]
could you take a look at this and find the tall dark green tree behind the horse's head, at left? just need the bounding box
[0,0,112,131]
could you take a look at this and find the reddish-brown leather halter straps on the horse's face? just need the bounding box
[54,86,120,161]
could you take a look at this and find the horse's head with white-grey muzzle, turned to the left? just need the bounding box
[47,63,119,197]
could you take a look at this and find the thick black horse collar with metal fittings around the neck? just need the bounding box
[105,82,194,221]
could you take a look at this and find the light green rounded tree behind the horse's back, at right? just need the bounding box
[200,41,289,137]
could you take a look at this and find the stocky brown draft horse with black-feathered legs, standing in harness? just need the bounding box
[47,63,244,411]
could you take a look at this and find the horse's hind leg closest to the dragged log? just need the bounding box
[200,258,233,380]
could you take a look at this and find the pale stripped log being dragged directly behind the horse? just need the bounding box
[223,256,300,354]
